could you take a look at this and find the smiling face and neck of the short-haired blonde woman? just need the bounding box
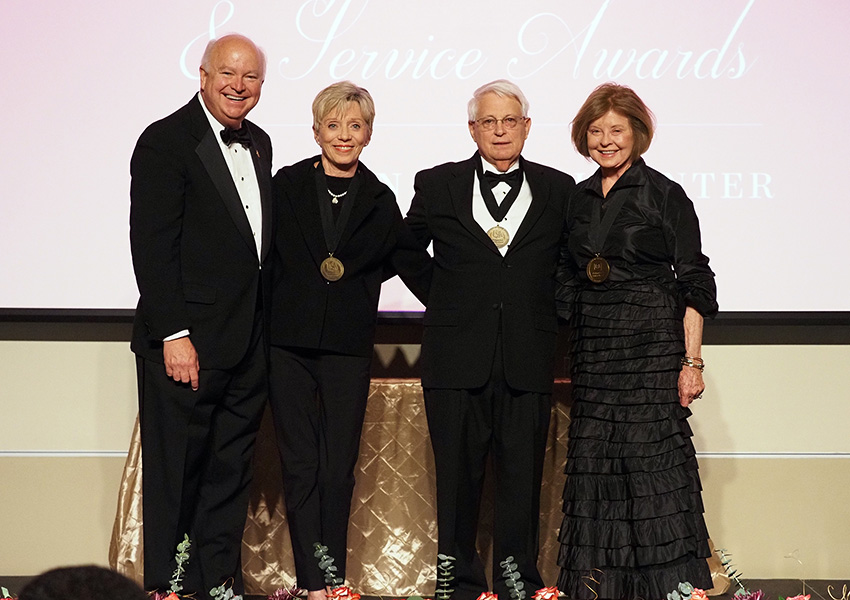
[313,102,372,177]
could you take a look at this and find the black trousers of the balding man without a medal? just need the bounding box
[136,317,268,598]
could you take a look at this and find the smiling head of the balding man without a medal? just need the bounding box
[201,36,264,129]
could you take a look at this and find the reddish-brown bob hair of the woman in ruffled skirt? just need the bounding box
[572,83,655,160]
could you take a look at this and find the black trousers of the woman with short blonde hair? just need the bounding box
[269,346,372,590]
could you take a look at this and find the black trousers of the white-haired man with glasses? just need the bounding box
[425,338,551,600]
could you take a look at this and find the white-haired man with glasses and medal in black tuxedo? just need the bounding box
[407,80,575,600]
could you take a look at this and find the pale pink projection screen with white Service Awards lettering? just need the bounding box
[0,0,850,312]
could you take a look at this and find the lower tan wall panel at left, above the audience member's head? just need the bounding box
[0,457,125,576]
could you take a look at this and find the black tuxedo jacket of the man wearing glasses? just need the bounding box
[407,154,575,393]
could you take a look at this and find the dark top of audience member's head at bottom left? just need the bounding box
[18,565,149,600]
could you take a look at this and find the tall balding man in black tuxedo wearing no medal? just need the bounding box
[130,35,273,598]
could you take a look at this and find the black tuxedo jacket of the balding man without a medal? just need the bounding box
[130,97,273,369]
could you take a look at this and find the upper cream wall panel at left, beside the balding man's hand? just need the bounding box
[0,341,138,452]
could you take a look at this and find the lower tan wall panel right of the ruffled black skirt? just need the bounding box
[700,458,850,582]
